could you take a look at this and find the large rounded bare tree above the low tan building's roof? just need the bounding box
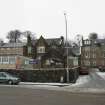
[7,30,22,43]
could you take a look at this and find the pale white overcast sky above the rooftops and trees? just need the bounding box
[0,0,105,39]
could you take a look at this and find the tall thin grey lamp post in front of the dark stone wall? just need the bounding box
[64,12,69,83]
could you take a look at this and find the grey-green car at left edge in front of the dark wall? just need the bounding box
[0,72,20,85]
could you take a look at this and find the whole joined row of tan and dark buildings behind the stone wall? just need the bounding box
[0,35,79,69]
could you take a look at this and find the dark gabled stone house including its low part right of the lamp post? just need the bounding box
[34,36,80,68]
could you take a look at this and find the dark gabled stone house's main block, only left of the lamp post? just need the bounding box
[34,36,64,68]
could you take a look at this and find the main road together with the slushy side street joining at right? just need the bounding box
[0,70,105,105]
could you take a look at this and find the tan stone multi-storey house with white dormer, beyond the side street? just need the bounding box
[81,39,105,67]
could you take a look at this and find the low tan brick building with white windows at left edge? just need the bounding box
[0,40,33,69]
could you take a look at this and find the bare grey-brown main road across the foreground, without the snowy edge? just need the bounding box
[0,85,105,105]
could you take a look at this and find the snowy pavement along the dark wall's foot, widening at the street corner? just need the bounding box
[19,75,105,93]
